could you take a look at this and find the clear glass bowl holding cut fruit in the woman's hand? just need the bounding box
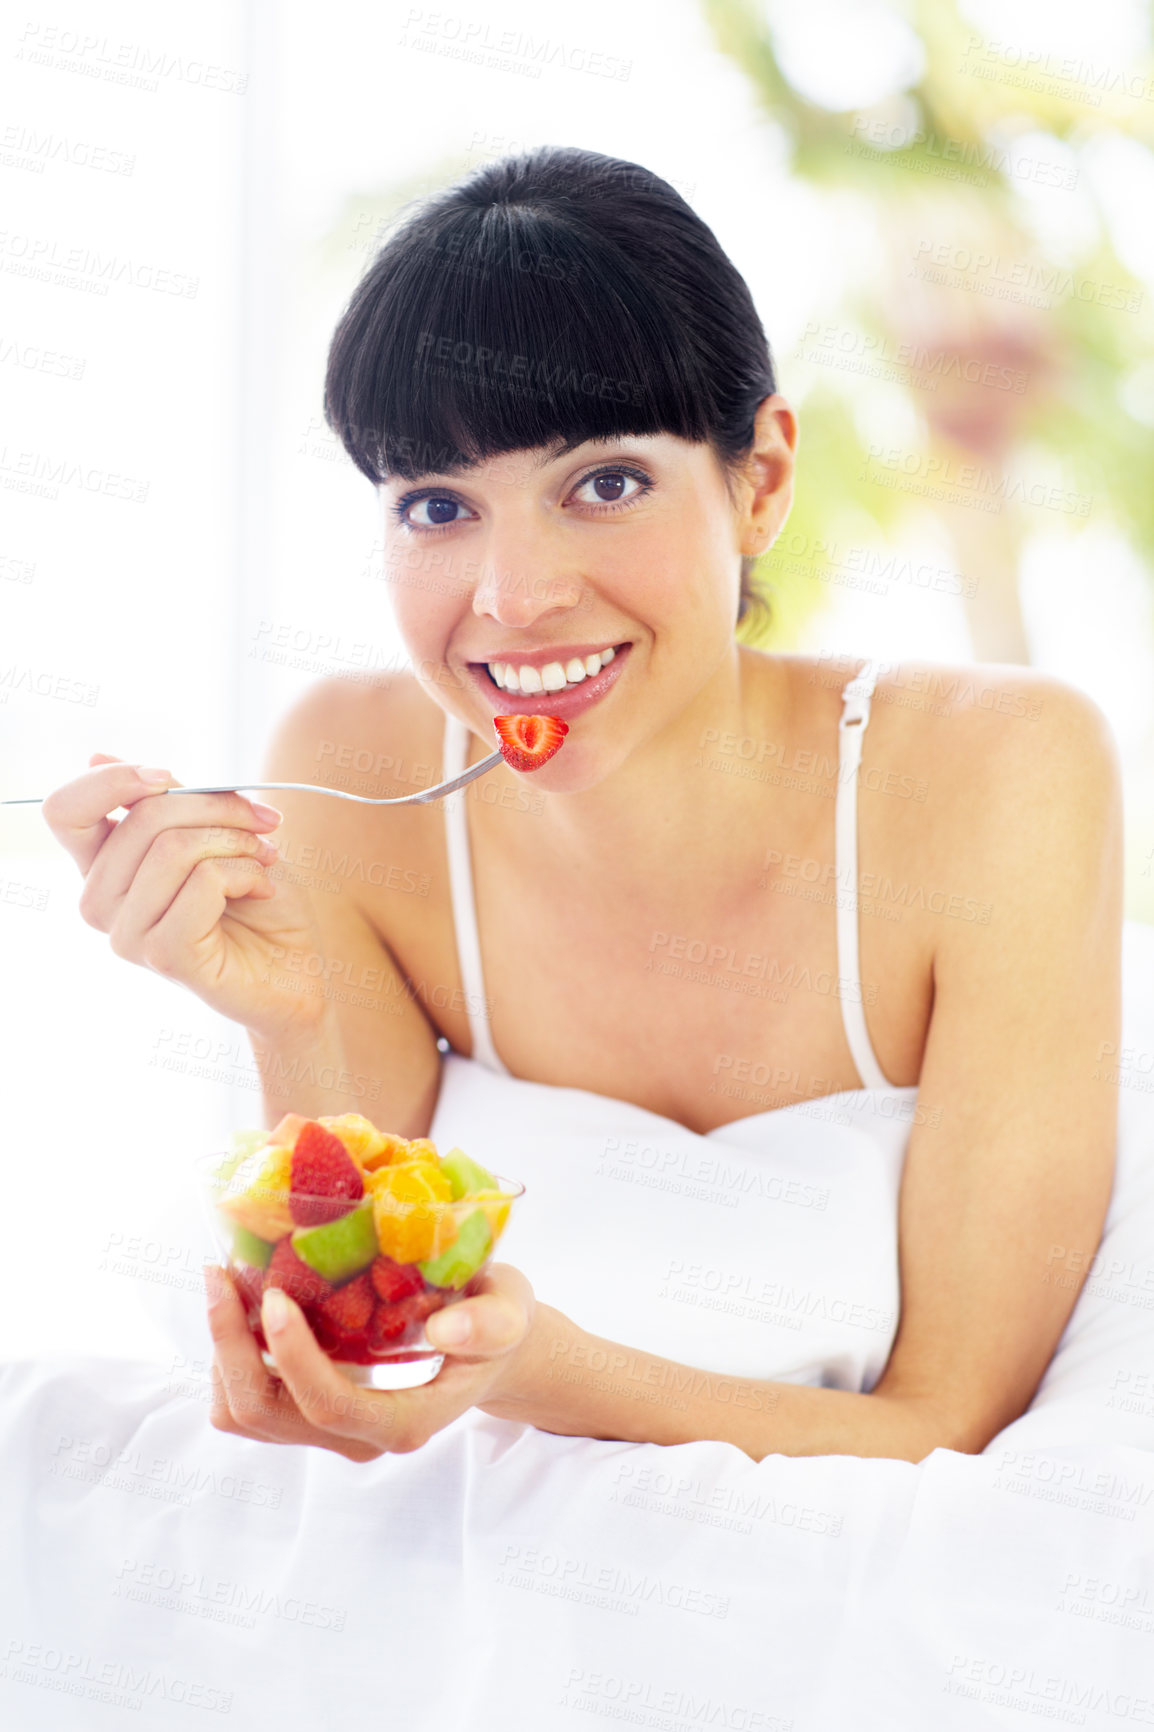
[194,1143,525,1389]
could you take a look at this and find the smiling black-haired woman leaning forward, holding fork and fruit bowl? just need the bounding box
[45,149,1121,1462]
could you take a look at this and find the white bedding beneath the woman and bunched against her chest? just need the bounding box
[0,925,1154,1732]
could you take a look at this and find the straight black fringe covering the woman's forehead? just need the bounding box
[326,206,709,481]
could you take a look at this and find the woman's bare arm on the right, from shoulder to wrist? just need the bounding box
[485,669,1121,1462]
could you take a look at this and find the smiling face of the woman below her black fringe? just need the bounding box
[379,398,792,793]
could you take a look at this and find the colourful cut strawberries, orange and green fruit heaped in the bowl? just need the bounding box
[208,1112,523,1365]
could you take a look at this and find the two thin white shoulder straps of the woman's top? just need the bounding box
[442,662,892,1089]
